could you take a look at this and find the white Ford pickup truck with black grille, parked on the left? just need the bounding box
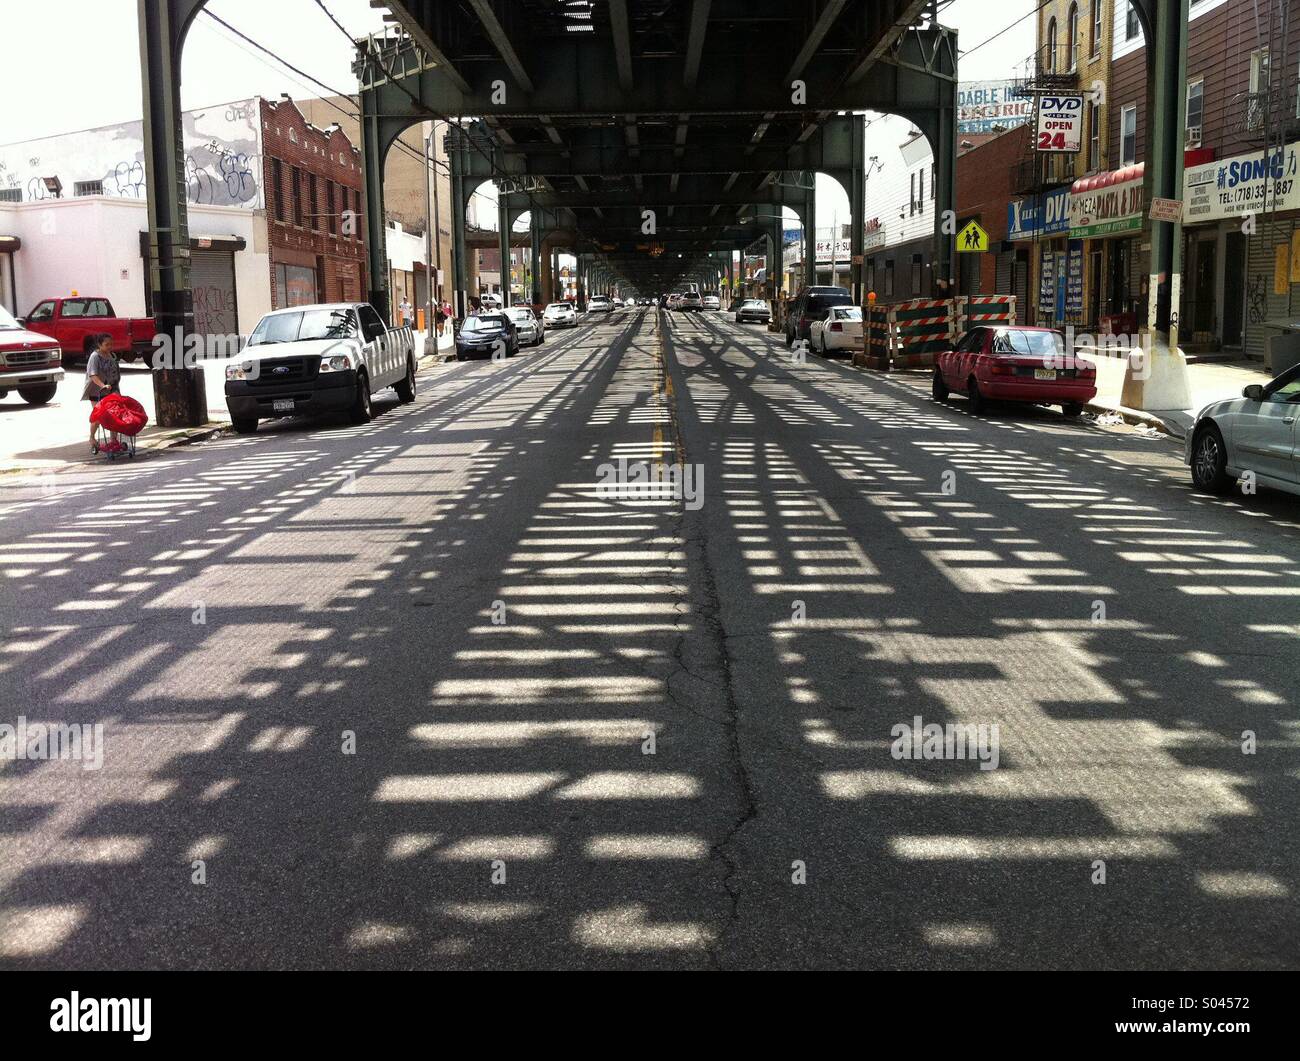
[226,302,415,434]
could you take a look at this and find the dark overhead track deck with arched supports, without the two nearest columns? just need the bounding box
[356,0,957,314]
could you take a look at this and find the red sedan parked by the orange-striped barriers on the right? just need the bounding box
[933,325,1097,416]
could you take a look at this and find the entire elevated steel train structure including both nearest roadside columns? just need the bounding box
[138,0,1188,426]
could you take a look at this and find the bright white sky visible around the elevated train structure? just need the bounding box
[0,0,1036,224]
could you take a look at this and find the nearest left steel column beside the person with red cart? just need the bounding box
[139,0,208,428]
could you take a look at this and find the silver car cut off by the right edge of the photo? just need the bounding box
[1184,365,1300,494]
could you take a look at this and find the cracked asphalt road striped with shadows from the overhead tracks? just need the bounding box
[0,311,1300,969]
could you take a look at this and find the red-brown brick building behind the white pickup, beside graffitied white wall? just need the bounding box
[259,99,367,309]
